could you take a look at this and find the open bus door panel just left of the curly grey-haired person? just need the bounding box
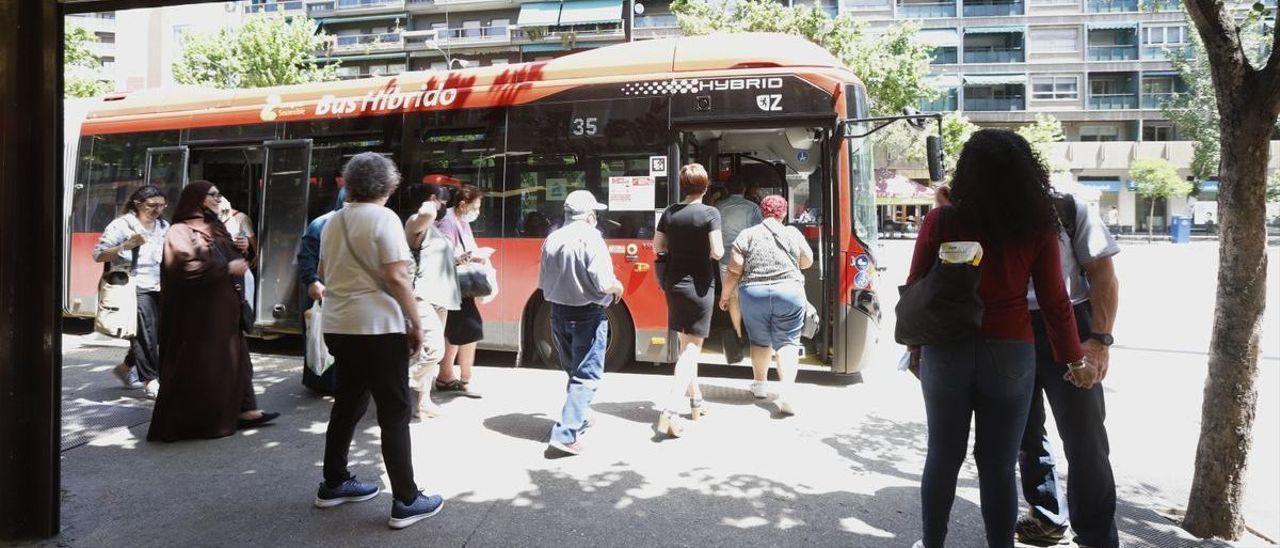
[255,140,311,330]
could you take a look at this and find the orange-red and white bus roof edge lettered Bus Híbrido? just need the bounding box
[83,33,856,133]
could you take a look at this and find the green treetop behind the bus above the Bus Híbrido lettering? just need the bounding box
[173,15,338,88]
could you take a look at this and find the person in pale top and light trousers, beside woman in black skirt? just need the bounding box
[404,183,462,419]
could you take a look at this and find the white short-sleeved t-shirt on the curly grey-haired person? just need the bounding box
[320,202,413,335]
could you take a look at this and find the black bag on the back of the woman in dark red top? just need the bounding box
[893,207,984,346]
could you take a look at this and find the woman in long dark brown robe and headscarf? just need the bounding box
[147,181,280,442]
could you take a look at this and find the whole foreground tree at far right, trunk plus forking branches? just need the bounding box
[1183,0,1280,540]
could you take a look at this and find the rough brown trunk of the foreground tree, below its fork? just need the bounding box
[1183,112,1274,540]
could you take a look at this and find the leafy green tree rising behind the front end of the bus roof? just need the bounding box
[671,0,937,115]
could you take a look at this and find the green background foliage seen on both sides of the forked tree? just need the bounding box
[1161,13,1270,179]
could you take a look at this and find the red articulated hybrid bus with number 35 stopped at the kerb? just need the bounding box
[64,35,879,374]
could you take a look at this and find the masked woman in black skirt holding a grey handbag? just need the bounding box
[435,184,489,398]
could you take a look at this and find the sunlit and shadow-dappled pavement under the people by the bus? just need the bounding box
[42,241,1280,547]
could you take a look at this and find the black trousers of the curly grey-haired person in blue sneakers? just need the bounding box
[324,333,417,503]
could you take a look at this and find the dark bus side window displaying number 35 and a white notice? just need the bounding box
[506,97,671,238]
